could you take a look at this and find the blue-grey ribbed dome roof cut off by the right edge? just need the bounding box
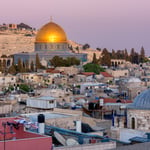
[127,89,150,109]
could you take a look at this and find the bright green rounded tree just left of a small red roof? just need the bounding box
[83,63,105,74]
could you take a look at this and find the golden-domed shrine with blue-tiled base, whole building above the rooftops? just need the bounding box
[14,21,87,64]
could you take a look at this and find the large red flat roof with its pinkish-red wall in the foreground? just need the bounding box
[0,118,52,150]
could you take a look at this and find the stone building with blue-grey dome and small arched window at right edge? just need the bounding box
[127,89,150,132]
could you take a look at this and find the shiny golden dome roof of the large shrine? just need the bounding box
[35,22,67,43]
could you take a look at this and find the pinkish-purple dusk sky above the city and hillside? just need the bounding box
[0,0,150,55]
